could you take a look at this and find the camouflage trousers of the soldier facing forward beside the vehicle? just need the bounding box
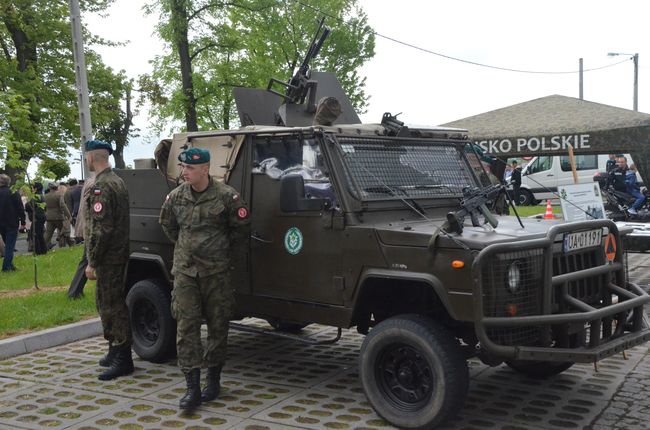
[172,272,234,372]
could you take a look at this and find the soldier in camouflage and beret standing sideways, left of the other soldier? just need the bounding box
[83,140,133,381]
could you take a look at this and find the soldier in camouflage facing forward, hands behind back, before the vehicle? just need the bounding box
[160,148,250,409]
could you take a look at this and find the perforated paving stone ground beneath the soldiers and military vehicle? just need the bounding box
[0,254,650,430]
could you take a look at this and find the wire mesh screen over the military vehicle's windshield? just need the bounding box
[337,136,476,200]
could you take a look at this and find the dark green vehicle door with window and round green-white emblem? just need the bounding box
[246,136,344,304]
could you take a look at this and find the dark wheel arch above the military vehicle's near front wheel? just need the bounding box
[352,269,457,332]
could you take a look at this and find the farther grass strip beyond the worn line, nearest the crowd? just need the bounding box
[0,246,84,291]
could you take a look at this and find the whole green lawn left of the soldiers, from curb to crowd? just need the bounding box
[0,246,97,339]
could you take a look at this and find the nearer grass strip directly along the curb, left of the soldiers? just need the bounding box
[0,283,97,339]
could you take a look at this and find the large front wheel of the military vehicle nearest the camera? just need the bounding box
[359,315,469,429]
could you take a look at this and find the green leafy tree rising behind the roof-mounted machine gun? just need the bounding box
[140,0,374,131]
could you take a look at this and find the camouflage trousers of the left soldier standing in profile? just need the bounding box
[95,264,131,346]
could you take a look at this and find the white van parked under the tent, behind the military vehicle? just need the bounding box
[519,154,641,205]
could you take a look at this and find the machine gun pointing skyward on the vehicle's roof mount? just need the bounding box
[266,18,330,113]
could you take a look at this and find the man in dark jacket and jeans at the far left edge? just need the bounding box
[0,174,25,272]
